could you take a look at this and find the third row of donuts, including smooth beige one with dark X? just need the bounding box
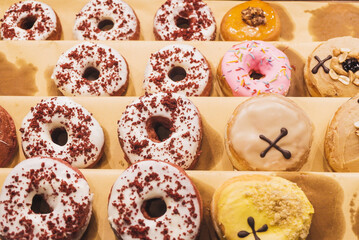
[0,93,359,172]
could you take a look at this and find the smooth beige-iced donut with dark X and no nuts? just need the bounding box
[225,94,313,171]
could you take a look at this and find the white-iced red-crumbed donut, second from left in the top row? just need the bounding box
[73,0,140,40]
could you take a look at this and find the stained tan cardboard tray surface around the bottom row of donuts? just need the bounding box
[0,169,359,240]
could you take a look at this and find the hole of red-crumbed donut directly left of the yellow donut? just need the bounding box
[141,198,167,220]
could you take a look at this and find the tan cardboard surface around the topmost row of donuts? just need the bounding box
[0,0,359,42]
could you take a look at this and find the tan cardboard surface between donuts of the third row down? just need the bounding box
[0,96,347,172]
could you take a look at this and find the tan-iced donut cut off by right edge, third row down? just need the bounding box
[324,94,359,172]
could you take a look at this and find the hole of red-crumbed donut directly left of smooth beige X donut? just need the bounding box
[146,116,174,142]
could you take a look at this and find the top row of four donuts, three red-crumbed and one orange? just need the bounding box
[0,0,280,41]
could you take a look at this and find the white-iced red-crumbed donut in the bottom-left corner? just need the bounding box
[0,157,93,240]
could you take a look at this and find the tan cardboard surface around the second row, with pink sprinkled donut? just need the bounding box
[0,41,319,97]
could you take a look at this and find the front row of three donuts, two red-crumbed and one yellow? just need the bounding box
[0,157,315,240]
